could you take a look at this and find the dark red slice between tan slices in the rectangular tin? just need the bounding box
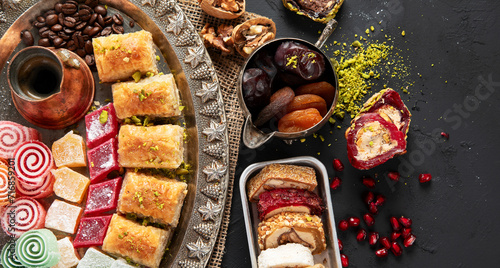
[257,188,323,220]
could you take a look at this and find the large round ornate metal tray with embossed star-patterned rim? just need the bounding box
[0,0,229,267]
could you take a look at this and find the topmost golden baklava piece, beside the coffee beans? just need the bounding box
[92,31,158,82]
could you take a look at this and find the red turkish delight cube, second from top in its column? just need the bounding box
[87,138,120,183]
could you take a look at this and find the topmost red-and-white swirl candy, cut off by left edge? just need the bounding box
[0,121,40,159]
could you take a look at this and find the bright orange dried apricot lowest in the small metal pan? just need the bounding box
[278,108,323,132]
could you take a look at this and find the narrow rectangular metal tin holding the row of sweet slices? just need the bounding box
[240,156,342,268]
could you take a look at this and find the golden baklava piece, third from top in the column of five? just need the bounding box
[118,125,184,169]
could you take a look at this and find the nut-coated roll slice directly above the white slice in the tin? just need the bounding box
[258,212,326,255]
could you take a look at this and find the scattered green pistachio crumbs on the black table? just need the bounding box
[325,29,414,124]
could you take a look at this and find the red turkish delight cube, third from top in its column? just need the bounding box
[84,177,122,215]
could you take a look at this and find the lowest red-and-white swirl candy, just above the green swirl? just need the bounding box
[0,197,46,238]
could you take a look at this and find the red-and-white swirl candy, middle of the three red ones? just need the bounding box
[14,141,54,187]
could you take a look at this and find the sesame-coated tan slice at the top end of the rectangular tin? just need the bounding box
[247,164,318,202]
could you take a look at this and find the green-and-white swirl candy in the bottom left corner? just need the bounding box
[16,229,61,268]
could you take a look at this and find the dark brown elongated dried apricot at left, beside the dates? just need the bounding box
[254,87,295,127]
